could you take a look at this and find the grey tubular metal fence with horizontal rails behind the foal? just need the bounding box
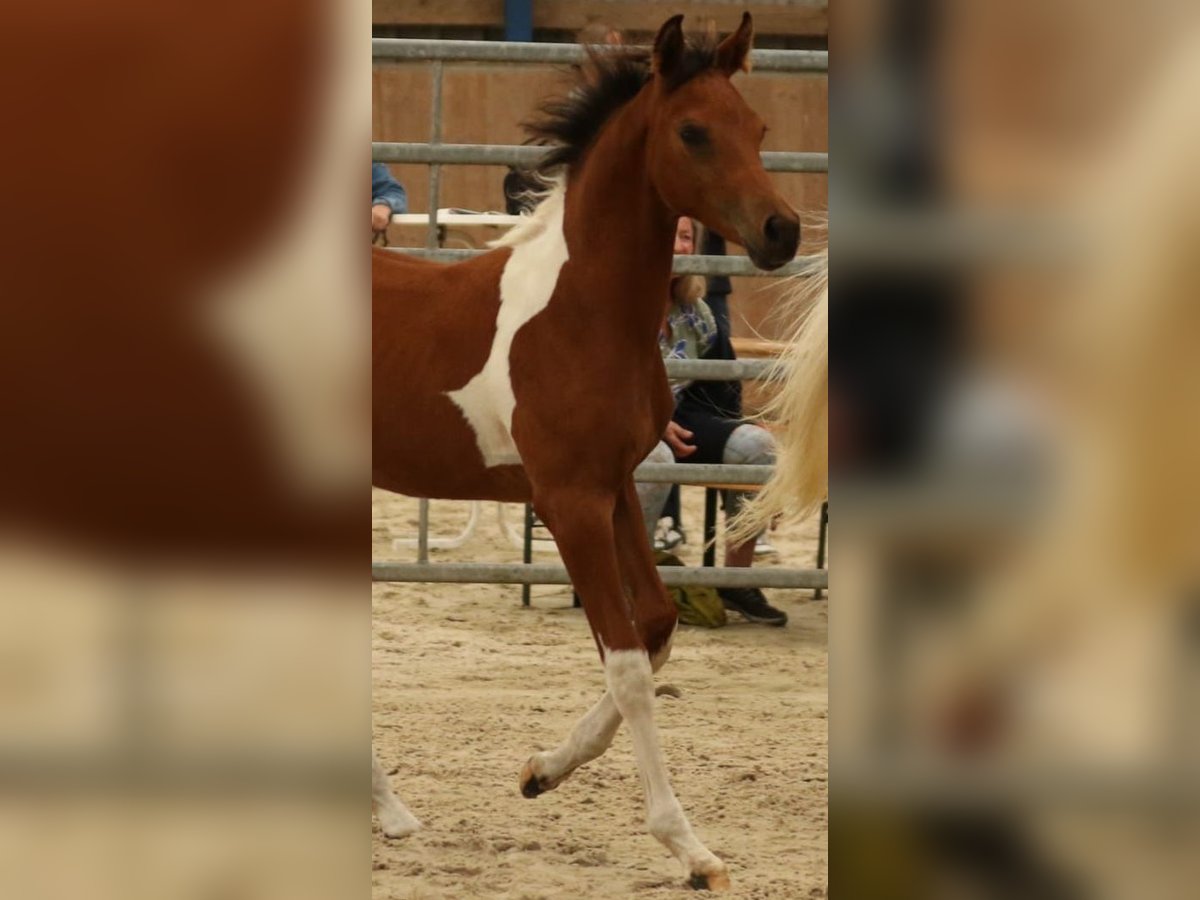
[371,38,829,600]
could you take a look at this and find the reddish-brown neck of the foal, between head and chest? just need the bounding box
[564,92,674,337]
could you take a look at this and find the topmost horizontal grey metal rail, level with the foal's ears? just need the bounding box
[371,37,829,72]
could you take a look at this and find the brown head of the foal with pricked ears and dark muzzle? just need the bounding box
[647,12,800,269]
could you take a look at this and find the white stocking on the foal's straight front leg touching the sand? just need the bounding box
[605,650,726,881]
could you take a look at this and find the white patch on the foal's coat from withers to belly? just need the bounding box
[448,186,569,467]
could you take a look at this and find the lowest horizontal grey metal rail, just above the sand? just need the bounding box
[371,560,829,590]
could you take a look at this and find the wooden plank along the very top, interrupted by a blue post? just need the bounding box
[372,0,829,36]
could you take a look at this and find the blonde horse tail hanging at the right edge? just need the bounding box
[727,251,829,542]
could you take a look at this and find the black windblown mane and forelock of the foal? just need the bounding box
[523,37,716,178]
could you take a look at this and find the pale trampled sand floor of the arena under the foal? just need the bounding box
[373,487,828,900]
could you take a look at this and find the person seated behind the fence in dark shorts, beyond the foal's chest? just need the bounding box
[637,217,787,625]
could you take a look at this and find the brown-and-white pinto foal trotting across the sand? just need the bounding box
[372,13,800,890]
